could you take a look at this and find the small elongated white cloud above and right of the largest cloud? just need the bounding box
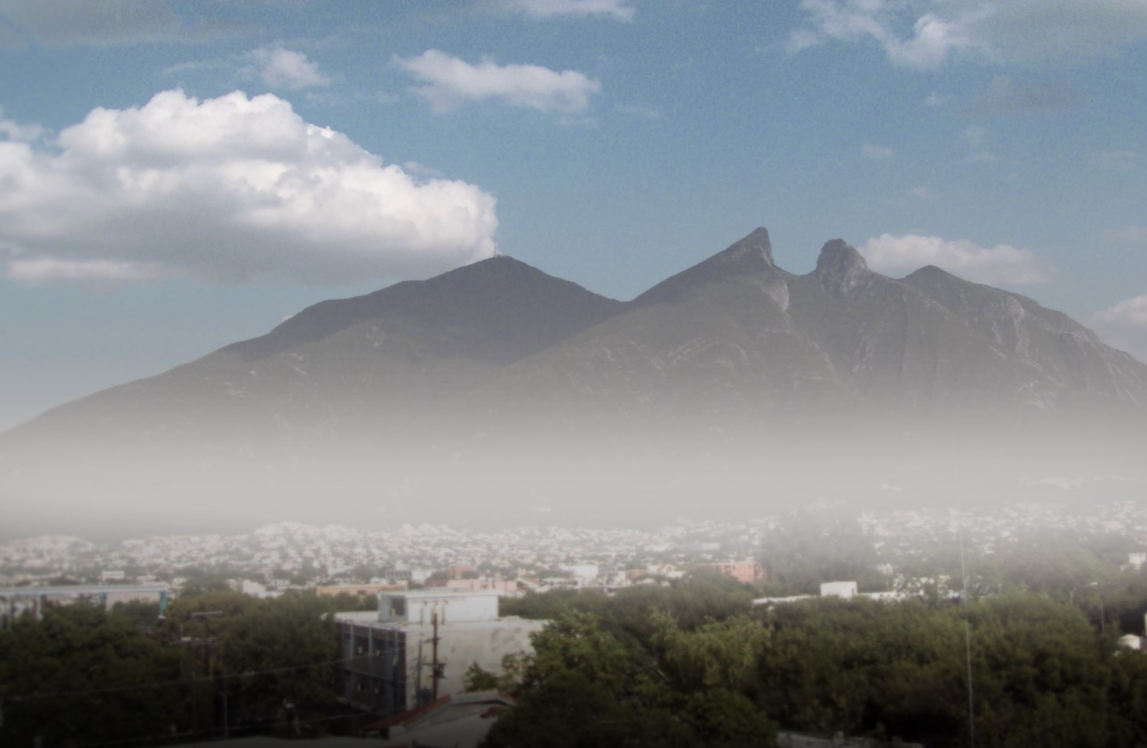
[395,49,601,114]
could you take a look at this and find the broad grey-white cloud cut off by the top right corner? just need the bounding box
[789,0,1147,69]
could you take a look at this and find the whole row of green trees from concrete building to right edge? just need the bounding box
[486,566,1147,748]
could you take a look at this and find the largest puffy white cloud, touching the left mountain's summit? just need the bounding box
[0,89,498,283]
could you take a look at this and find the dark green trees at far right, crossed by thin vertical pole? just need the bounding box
[760,593,1147,748]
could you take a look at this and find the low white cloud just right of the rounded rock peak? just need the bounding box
[859,234,1051,286]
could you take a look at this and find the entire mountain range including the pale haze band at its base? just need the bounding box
[0,228,1147,535]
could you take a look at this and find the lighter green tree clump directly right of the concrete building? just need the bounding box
[485,610,775,748]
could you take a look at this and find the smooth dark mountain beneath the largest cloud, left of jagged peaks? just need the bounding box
[0,256,623,444]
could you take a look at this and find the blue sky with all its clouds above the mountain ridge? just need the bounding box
[0,0,1147,428]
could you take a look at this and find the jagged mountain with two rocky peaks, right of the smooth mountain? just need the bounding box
[486,228,1147,419]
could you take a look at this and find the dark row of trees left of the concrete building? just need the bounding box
[0,591,352,748]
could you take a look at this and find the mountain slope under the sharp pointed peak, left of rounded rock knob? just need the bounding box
[477,228,845,416]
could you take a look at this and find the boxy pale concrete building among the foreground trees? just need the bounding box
[335,590,546,717]
